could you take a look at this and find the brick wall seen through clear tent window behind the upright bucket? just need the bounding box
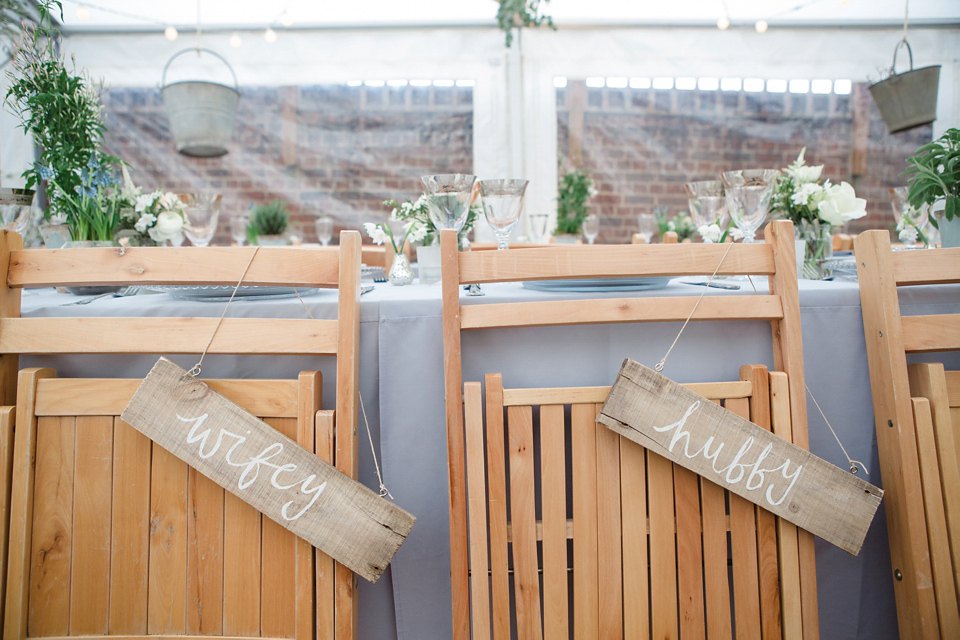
[104,85,473,244]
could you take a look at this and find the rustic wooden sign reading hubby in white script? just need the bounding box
[597,359,883,555]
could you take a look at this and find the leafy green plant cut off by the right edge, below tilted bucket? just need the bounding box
[903,129,960,226]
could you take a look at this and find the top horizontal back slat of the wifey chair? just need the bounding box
[7,247,340,288]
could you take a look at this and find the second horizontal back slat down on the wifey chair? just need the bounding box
[0,318,337,355]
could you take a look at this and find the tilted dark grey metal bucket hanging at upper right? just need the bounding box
[870,39,940,133]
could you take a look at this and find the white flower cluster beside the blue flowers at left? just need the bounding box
[116,167,186,247]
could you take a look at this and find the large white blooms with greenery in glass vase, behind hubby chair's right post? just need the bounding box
[770,147,867,279]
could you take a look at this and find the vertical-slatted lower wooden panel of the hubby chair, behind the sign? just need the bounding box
[464,366,803,639]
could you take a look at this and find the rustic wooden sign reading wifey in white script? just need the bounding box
[120,358,416,582]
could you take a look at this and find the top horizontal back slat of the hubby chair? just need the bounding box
[459,243,774,284]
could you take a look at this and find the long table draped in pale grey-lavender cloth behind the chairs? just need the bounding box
[21,278,960,640]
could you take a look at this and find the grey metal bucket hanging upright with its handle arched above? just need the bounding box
[160,48,240,158]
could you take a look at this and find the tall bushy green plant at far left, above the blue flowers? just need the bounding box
[5,0,109,222]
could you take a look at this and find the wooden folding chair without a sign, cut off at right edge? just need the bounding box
[854,230,960,639]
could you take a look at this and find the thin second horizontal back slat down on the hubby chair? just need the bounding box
[460,296,783,331]
